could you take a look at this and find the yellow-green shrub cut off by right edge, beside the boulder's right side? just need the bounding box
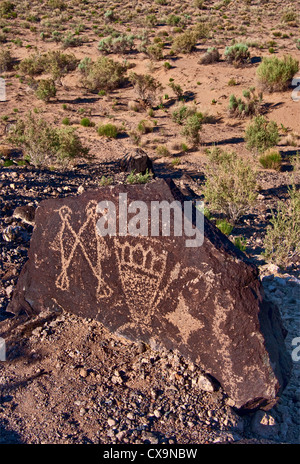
[264,185,300,266]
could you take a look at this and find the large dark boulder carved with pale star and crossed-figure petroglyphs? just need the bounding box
[8,179,291,409]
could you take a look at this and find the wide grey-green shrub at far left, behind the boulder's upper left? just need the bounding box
[9,113,88,166]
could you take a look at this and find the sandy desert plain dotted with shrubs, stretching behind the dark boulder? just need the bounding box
[0,0,300,272]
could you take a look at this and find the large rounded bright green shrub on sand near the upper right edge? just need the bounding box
[257,55,299,92]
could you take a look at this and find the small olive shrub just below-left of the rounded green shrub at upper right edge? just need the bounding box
[228,88,262,118]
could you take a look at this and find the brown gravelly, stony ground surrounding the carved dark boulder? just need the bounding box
[0,162,300,444]
